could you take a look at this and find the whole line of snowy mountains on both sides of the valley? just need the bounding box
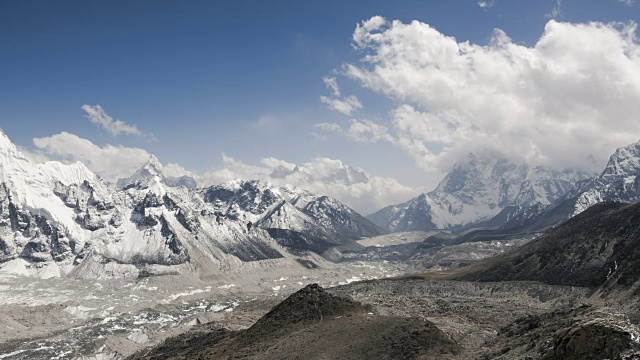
[0,122,640,277]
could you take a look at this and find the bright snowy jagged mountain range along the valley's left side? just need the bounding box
[0,129,380,278]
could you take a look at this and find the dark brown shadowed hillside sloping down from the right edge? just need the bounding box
[457,203,640,288]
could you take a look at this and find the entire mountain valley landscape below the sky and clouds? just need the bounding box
[0,129,640,360]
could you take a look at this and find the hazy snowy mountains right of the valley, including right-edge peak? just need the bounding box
[367,142,640,235]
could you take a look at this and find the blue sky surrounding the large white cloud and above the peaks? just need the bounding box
[0,0,640,212]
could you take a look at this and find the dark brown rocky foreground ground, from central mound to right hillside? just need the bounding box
[130,203,640,359]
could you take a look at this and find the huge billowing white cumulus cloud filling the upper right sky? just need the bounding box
[328,17,640,171]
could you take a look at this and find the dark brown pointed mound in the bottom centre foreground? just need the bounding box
[131,284,461,359]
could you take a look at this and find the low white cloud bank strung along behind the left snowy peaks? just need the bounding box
[28,132,425,213]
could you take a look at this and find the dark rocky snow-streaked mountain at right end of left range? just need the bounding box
[200,180,383,251]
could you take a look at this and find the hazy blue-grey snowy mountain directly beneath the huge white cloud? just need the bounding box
[368,154,587,231]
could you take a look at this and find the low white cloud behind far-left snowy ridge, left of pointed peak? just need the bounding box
[33,132,151,181]
